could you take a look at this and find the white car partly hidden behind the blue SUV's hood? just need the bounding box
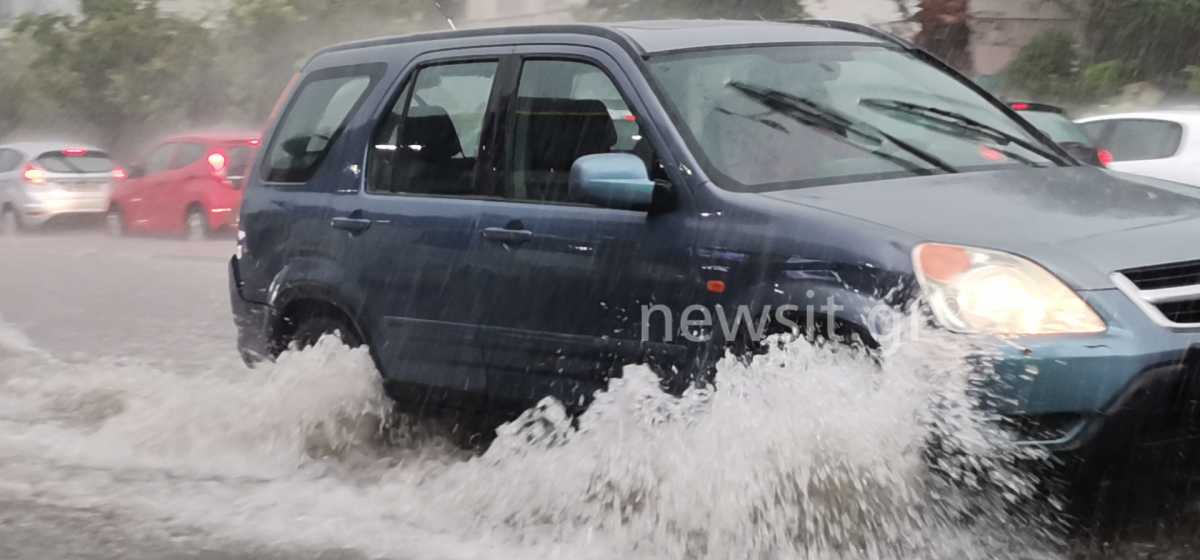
[1076,112,1200,186]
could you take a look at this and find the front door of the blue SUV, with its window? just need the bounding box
[473,47,695,407]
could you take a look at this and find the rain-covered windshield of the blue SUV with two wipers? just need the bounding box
[650,44,1069,191]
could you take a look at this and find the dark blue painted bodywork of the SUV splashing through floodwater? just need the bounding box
[232,24,1200,460]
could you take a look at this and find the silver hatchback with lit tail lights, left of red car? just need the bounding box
[0,143,118,235]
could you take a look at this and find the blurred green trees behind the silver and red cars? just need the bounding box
[0,0,444,145]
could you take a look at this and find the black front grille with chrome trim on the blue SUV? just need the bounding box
[1112,260,1200,327]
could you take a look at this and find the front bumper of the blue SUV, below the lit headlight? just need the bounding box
[988,289,1200,472]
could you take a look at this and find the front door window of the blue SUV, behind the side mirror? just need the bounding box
[508,60,655,203]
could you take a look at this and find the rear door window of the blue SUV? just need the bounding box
[367,61,498,195]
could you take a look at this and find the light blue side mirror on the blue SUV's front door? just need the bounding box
[568,153,654,210]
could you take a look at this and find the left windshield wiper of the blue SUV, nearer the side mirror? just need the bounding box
[728,82,956,175]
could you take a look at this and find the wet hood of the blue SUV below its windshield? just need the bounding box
[764,167,1200,290]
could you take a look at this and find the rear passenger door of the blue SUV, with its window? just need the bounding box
[332,48,511,408]
